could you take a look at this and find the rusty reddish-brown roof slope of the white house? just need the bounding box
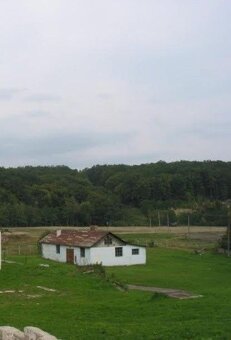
[40,230,110,247]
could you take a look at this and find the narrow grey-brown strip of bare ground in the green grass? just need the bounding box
[127,285,202,299]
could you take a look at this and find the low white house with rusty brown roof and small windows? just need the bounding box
[40,229,146,266]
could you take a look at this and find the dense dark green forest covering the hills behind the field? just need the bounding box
[0,161,231,227]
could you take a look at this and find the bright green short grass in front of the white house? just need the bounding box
[0,248,231,340]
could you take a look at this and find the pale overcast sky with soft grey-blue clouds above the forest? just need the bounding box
[0,0,231,169]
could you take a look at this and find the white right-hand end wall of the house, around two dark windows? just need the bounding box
[90,245,146,266]
